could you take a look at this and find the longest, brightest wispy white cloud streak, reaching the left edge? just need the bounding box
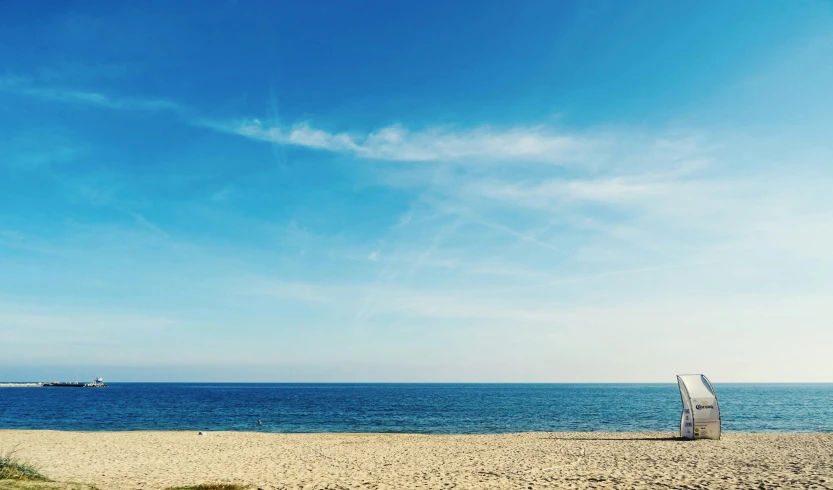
[0,75,604,166]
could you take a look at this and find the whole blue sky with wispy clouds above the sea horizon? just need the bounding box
[0,1,833,382]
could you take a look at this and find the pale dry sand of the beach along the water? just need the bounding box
[0,430,833,490]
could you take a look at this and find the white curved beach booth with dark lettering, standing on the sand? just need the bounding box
[677,374,720,439]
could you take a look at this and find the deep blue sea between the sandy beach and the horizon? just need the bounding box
[0,383,833,434]
